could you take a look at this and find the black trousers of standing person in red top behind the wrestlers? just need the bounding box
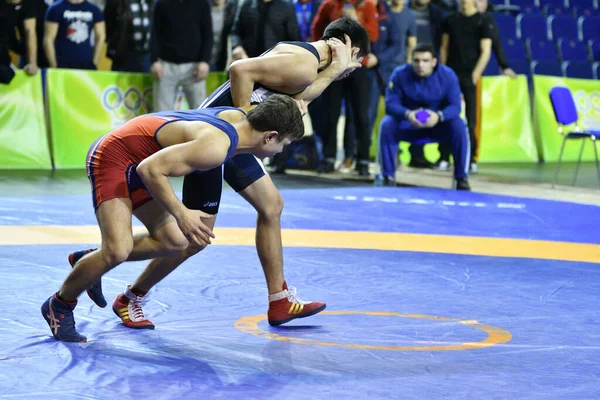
[317,68,371,163]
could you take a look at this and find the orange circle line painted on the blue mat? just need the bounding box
[235,311,512,351]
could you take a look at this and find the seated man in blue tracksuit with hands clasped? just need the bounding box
[379,44,470,190]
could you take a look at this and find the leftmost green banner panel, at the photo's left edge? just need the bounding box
[0,71,52,169]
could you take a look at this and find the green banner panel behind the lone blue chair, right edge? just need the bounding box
[533,75,600,161]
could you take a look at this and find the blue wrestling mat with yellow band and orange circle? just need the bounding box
[0,187,600,400]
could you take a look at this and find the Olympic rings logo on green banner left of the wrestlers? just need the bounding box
[102,85,152,126]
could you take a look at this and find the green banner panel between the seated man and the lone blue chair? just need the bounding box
[478,75,538,162]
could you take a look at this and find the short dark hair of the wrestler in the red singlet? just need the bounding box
[246,94,304,142]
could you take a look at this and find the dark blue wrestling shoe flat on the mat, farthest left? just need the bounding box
[42,293,87,343]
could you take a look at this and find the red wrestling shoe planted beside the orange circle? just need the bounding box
[267,282,326,326]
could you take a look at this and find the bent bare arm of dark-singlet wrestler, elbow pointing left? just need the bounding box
[229,52,318,107]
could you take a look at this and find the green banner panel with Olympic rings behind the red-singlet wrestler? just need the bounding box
[47,69,227,168]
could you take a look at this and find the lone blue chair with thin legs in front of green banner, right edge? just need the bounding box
[550,86,600,187]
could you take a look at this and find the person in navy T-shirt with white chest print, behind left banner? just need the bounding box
[44,0,106,69]
